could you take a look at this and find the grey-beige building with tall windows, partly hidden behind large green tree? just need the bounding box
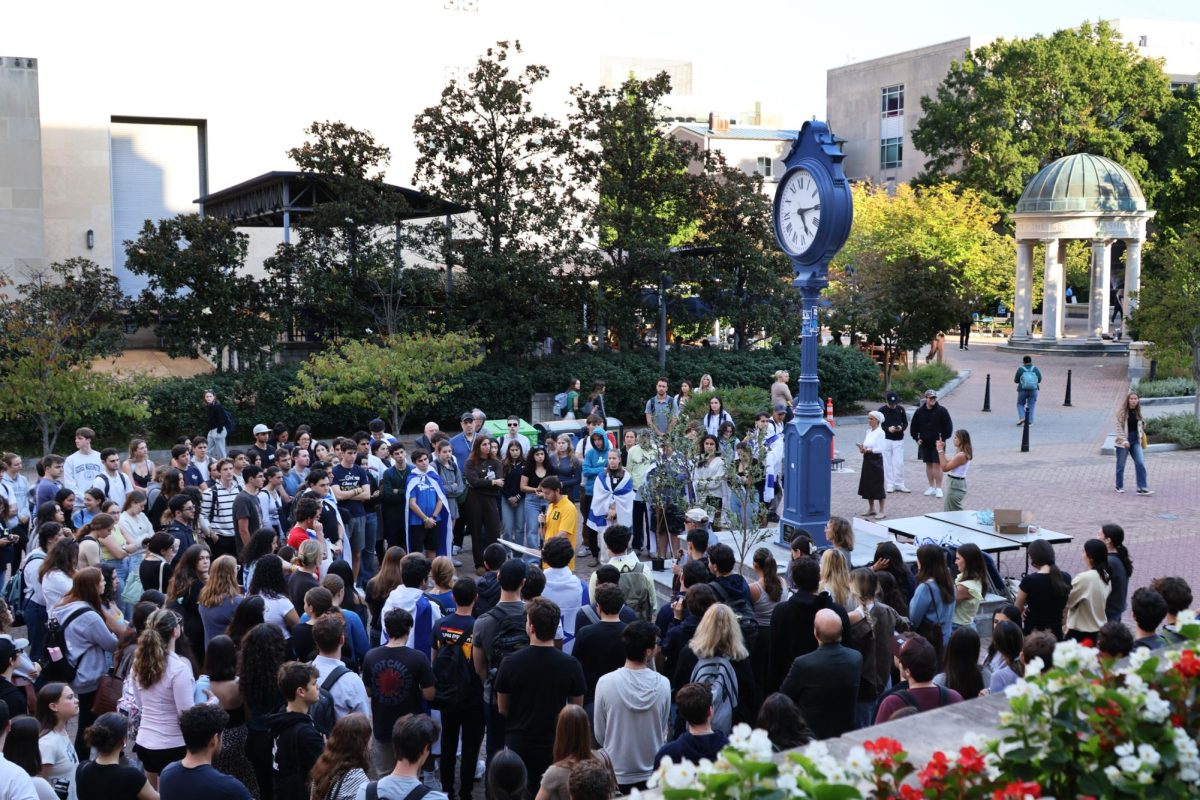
[826,18,1200,185]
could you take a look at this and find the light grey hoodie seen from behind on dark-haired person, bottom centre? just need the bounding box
[592,667,671,786]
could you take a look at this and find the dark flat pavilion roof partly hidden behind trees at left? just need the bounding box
[194,172,470,228]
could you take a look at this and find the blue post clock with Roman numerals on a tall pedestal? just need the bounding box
[774,120,854,545]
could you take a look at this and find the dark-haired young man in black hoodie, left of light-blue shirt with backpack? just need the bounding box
[266,661,325,799]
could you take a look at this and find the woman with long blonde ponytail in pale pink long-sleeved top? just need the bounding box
[132,608,196,789]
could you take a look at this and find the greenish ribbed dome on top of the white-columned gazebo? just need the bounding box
[1016,152,1146,212]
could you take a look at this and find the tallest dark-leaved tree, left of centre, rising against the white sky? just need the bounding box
[413,42,582,354]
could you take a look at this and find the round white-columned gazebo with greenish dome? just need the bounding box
[1010,154,1154,348]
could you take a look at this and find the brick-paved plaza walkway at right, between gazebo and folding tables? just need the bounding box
[833,337,1200,599]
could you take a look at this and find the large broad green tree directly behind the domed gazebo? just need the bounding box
[912,22,1171,206]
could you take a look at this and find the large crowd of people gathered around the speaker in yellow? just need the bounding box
[0,374,1192,800]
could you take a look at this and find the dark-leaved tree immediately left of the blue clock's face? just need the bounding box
[690,151,799,350]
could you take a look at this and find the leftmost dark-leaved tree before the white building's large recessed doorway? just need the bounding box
[125,213,281,369]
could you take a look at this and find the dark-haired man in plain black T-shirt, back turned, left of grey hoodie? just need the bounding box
[496,597,587,795]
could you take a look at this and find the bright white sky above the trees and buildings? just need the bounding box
[7,0,1200,188]
